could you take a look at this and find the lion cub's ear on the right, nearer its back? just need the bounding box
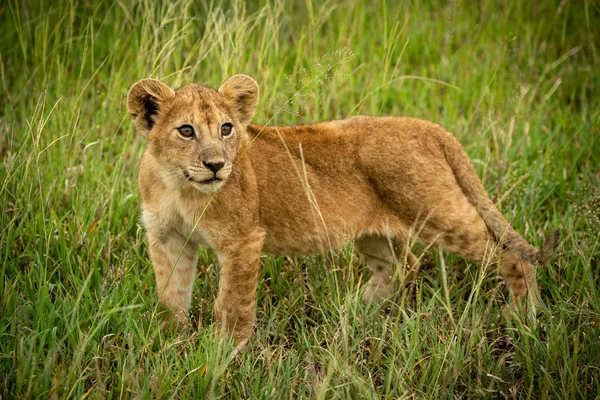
[219,75,258,125]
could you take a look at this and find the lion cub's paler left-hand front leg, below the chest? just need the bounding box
[148,222,199,326]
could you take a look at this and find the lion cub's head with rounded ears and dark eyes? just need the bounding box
[127,75,258,193]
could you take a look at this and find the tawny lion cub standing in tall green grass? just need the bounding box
[127,75,558,339]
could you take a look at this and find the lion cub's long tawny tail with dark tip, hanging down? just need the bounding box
[440,132,560,264]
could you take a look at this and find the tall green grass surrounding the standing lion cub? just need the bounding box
[0,0,600,399]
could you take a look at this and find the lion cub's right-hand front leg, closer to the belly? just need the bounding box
[215,228,265,340]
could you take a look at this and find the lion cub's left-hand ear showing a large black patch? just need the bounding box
[127,78,175,136]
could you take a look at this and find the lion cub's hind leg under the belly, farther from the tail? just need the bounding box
[354,235,419,303]
